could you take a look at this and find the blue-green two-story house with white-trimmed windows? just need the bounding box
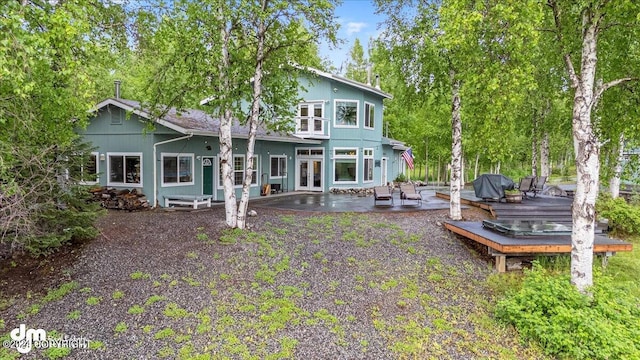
[80,70,406,205]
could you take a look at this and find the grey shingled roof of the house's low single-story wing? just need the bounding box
[95,98,321,144]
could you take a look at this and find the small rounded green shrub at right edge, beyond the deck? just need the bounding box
[596,193,640,235]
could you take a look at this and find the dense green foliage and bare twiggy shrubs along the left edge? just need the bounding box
[0,0,124,255]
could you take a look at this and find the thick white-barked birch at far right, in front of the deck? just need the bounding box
[547,0,640,293]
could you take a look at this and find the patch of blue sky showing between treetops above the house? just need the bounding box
[320,0,385,74]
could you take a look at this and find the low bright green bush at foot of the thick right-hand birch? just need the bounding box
[496,262,640,359]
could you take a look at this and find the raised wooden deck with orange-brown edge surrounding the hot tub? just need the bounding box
[436,192,633,272]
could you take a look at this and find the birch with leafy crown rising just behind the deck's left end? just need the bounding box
[378,0,539,220]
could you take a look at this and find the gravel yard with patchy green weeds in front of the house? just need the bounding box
[0,207,538,359]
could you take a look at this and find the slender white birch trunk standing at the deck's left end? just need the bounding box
[449,70,462,220]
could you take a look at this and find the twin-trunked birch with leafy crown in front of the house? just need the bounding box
[141,0,336,228]
